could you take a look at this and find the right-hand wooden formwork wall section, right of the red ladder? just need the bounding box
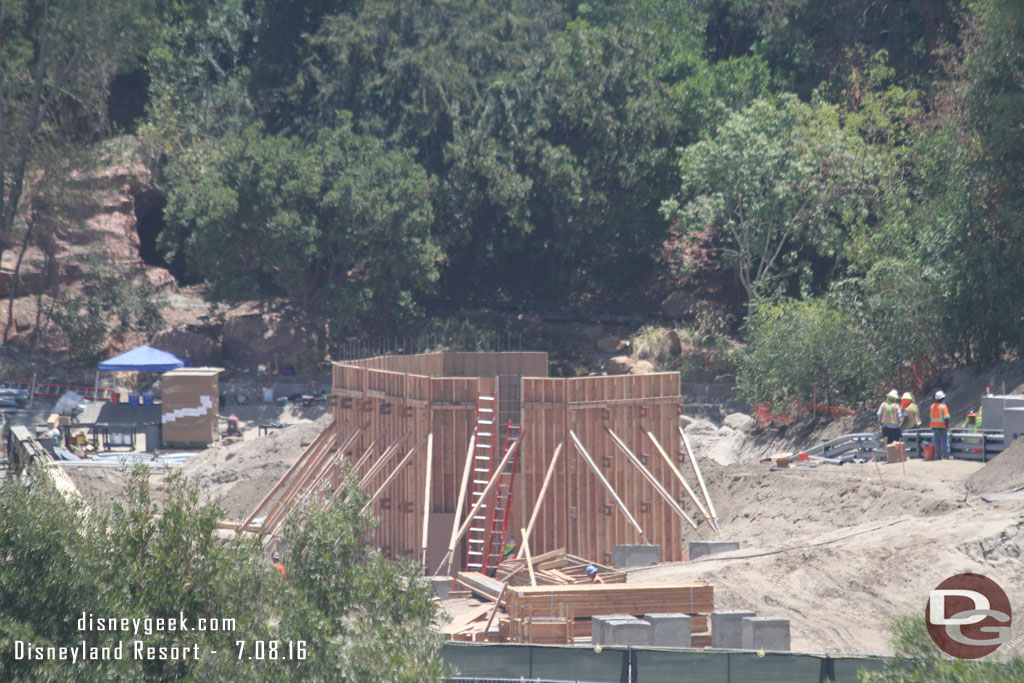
[510,373,685,564]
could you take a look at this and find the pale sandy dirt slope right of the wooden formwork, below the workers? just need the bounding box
[628,459,1024,653]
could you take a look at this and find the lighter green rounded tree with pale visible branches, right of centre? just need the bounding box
[663,95,882,304]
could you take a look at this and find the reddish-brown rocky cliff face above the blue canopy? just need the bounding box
[0,143,309,367]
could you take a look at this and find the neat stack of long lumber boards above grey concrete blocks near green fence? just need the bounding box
[505,581,715,646]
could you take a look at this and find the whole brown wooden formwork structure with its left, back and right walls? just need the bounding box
[333,353,682,569]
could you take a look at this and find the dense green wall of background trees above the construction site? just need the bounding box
[6,0,1024,401]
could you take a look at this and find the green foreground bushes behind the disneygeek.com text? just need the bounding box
[0,471,444,681]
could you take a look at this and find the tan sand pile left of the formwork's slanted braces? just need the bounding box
[182,414,332,520]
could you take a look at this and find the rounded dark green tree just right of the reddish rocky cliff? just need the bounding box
[161,118,442,342]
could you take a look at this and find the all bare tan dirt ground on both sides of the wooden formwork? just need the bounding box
[58,397,1024,653]
